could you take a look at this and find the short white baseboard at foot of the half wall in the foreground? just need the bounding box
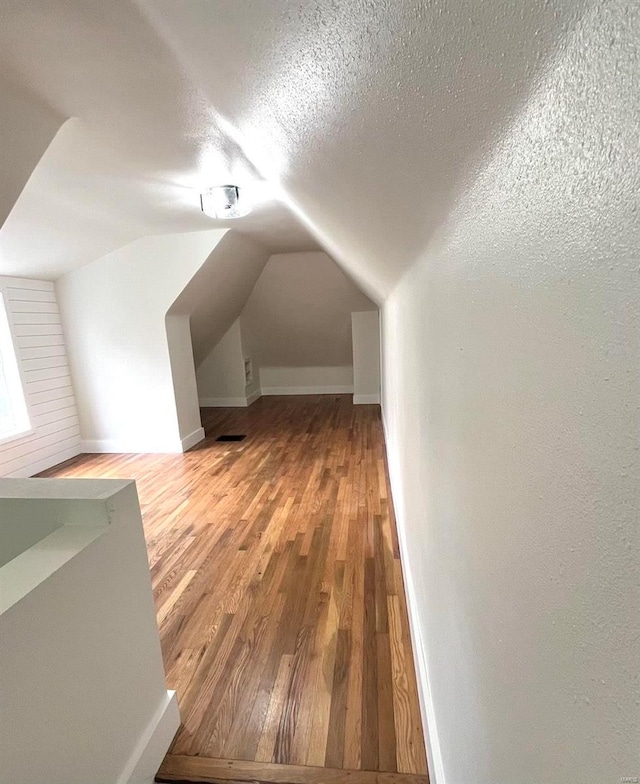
[117,691,180,784]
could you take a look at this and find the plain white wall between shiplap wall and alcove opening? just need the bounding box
[57,230,225,452]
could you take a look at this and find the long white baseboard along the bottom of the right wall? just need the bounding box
[381,408,446,784]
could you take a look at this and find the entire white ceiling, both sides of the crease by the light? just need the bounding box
[0,0,583,290]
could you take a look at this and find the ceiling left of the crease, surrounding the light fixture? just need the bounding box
[0,0,319,279]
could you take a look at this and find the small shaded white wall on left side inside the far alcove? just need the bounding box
[196,319,247,406]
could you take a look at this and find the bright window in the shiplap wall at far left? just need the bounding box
[0,291,31,443]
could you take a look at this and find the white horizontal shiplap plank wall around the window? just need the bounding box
[0,277,80,476]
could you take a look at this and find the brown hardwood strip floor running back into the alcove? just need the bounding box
[44,395,427,782]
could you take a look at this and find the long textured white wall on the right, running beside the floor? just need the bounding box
[383,2,640,784]
